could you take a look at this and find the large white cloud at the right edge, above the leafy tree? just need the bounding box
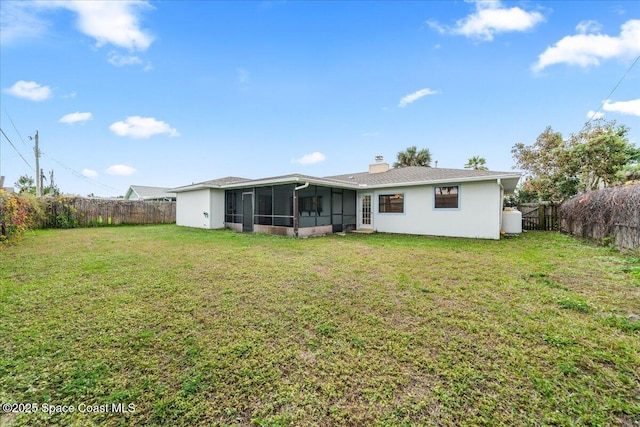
[532,19,640,71]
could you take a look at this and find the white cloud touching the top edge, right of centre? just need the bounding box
[427,1,545,41]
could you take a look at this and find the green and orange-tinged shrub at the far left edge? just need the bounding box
[0,190,42,243]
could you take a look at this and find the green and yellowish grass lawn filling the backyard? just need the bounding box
[0,225,640,427]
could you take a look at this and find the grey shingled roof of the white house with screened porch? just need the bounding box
[171,166,521,193]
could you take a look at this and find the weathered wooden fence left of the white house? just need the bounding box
[40,197,176,228]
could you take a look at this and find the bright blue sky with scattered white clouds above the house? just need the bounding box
[0,0,640,196]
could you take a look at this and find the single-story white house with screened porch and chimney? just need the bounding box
[171,163,521,239]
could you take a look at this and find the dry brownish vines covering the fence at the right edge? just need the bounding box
[560,184,640,252]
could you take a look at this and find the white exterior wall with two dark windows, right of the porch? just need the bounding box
[368,182,502,239]
